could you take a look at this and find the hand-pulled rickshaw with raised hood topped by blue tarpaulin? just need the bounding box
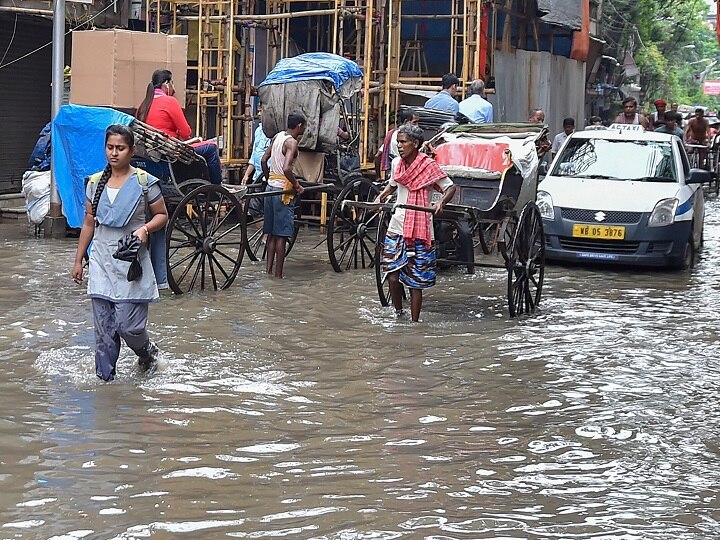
[243,53,379,272]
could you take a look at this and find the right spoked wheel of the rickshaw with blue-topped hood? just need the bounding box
[327,175,382,272]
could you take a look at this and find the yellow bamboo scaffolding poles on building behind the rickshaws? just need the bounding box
[151,0,498,177]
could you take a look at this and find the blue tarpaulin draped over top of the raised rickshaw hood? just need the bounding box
[260,52,363,92]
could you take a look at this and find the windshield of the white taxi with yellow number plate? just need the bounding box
[552,138,678,182]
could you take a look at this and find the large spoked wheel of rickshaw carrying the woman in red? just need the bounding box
[167,184,245,294]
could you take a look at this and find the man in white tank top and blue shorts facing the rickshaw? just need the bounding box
[261,112,306,278]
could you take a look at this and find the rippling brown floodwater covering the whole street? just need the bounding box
[0,200,720,540]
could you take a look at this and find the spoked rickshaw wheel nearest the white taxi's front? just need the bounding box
[506,202,545,317]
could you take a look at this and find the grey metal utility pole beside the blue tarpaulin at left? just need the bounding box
[43,0,66,238]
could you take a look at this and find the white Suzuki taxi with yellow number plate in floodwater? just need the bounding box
[537,125,711,269]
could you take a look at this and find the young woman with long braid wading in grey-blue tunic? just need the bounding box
[72,125,168,381]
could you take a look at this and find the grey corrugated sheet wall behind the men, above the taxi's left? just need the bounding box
[489,50,585,140]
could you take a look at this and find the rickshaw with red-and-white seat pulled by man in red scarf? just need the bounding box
[340,124,547,317]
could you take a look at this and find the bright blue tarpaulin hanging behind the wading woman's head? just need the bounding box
[52,105,134,228]
